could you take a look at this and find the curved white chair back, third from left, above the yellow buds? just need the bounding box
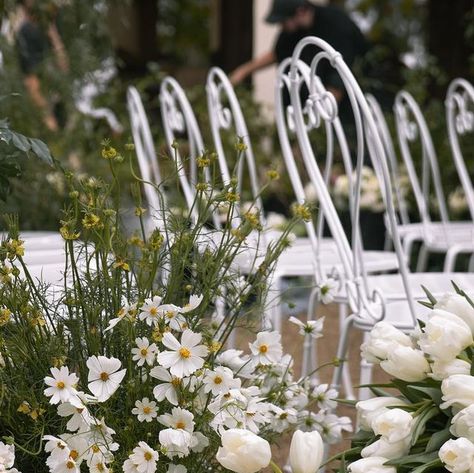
[206,67,264,219]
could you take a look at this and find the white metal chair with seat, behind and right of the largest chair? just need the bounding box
[394,91,474,272]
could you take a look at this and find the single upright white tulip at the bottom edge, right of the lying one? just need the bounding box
[290,430,324,473]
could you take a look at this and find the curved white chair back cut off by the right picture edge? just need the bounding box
[445,79,474,220]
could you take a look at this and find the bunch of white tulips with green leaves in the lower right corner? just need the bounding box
[339,288,474,473]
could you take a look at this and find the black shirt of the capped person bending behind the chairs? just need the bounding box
[274,5,368,120]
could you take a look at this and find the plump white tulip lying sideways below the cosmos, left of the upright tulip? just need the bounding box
[216,429,272,473]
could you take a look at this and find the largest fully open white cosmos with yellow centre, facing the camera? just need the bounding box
[158,329,208,378]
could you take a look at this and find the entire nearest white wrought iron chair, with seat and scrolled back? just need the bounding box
[290,37,474,398]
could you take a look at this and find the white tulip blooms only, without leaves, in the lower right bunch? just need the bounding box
[349,294,474,473]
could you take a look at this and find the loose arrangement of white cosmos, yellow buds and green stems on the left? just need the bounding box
[0,142,351,473]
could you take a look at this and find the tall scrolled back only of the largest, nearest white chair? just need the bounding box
[289,37,416,328]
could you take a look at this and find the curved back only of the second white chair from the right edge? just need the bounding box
[394,90,449,239]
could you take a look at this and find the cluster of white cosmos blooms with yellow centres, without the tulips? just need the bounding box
[39,295,344,473]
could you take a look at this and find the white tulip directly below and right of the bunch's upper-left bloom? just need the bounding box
[380,346,430,382]
